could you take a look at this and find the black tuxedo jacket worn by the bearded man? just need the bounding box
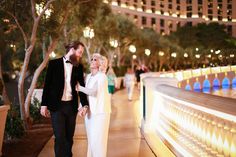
[41,58,89,112]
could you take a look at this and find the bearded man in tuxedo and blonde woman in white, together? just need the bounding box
[40,41,111,157]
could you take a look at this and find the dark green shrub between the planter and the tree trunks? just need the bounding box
[5,105,24,139]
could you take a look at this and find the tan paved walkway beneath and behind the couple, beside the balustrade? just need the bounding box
[39,88,155,157]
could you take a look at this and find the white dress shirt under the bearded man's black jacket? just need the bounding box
[61,57,73,101]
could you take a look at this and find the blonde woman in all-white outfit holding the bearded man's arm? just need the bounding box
[77,54,111,157]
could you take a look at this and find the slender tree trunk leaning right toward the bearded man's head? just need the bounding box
[24,39,58,121]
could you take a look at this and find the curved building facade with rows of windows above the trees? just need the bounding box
[104,0,236,37]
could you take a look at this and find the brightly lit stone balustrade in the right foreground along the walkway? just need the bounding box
[140,65,236,157]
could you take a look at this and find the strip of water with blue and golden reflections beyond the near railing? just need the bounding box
[202,86,236,99]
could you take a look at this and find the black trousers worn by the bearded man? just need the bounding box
[50,101,77,157]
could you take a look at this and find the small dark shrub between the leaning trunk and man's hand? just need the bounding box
[30,97,42,122]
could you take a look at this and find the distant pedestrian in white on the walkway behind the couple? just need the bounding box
[124,68,135,101]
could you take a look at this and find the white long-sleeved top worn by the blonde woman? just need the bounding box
[79,72,111,114]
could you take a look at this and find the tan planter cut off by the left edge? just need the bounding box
[0,105,10,156]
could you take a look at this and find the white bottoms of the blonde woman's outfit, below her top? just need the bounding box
[85,113,110,157]
